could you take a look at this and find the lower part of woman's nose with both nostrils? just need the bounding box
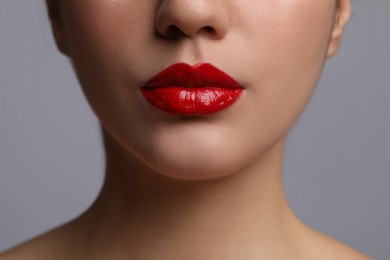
[156,0,229,39]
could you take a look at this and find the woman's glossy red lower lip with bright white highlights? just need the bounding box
[142,86,242,116]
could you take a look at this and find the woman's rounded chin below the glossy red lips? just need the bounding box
[130,127,278,181]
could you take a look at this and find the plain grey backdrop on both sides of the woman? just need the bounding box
[0,0,390,259]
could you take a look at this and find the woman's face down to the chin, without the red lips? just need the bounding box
[48,0,348,179]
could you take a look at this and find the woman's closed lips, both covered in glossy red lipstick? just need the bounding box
[141,63,243,116]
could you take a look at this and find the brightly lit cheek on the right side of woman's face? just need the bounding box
[236,0,334,136]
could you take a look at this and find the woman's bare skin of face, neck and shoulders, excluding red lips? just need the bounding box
[0,0,368,260]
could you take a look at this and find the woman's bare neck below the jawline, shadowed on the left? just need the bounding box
[77,129,304,259]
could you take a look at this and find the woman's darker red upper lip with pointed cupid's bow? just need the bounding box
[144,63,242,89]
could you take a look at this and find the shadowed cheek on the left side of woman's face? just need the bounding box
[63,0,155,121]
